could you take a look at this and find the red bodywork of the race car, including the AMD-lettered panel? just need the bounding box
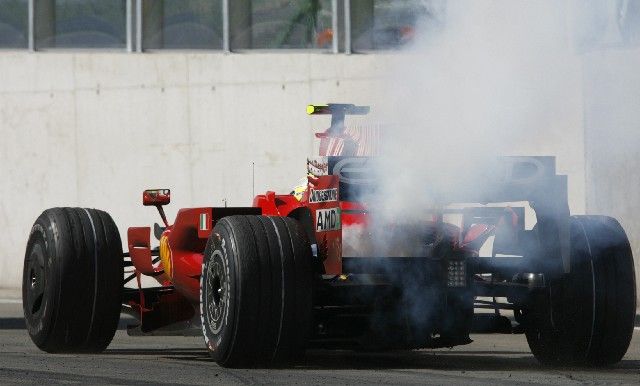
[127,176,356,330]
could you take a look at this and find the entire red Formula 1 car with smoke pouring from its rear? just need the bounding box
[23,104,636,366]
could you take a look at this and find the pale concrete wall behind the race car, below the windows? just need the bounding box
[0,52,585,287]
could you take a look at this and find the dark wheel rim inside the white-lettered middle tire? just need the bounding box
[206,251,229,334]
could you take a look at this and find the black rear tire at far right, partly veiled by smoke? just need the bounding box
[525,216,636,366]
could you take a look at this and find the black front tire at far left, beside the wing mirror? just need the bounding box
[22,208,123,353]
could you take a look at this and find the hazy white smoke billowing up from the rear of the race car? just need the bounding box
[343,0,640,344]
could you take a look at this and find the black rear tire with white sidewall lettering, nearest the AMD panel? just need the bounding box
[200,216,312,367]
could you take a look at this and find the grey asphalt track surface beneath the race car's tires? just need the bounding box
[0,308,640,385]
